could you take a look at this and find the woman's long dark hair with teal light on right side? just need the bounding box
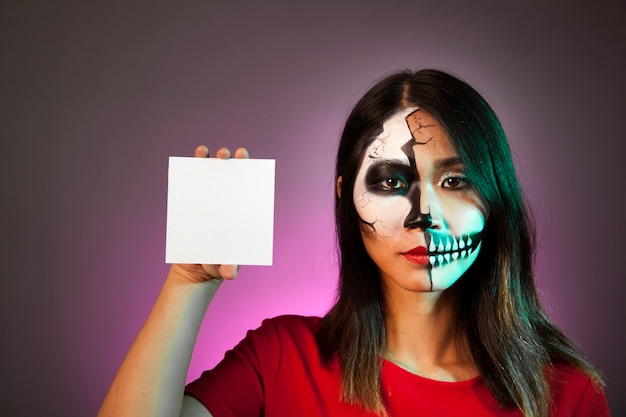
[318,70,600,417]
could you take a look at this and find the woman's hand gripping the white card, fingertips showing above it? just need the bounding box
[171,145,250,282]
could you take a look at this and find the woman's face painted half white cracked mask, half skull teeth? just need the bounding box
[353,107,485,291]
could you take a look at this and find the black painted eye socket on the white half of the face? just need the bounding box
[365,162,417,195]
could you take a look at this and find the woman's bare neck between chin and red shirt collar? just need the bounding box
[385,282,477,381]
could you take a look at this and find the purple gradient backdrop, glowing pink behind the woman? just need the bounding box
[0,0,626,416]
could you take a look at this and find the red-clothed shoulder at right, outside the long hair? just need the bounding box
[548,364,610,417]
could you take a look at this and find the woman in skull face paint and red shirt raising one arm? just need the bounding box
[100,70,609,417]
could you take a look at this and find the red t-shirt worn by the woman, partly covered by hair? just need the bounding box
[186,316,610,417]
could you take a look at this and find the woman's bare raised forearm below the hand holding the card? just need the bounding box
[98,265,221,417]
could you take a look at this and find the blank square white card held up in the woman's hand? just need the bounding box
[165,156,275,265]
